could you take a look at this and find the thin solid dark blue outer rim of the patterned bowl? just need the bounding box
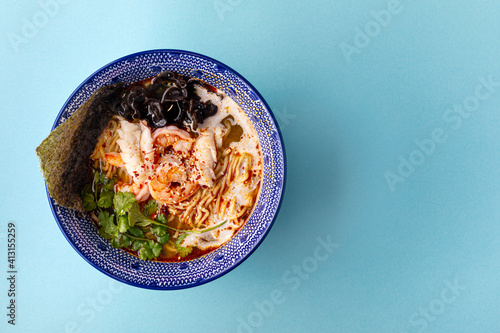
[46,49,287,290]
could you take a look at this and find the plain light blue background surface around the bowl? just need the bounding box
[0,0,500,333]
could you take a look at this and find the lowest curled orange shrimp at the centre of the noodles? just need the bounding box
[149,155,200,204]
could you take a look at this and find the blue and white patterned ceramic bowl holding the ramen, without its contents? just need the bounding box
[49,50,286,289]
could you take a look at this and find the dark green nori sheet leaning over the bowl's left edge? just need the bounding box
[35,82,125,211]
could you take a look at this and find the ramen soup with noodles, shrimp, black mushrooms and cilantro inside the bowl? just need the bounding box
[82,72,262,261]
